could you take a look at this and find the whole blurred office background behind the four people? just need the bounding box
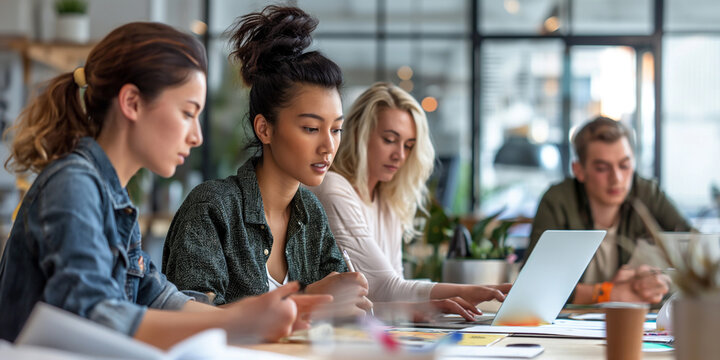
[0,0,720,257]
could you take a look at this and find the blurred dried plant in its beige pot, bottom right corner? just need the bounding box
[633,200,720,360]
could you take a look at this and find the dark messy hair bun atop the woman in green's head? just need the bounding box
[230,5,318,86]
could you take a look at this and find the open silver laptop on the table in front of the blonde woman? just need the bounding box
[415,230,607,328]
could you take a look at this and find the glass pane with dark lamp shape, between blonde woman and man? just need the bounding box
[480,39,564,217]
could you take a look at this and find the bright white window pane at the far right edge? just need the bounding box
[659,0,720,232]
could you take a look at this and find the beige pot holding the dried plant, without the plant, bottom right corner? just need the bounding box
[672,293,720,360]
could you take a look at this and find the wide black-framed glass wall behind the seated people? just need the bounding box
[194,0,720,225]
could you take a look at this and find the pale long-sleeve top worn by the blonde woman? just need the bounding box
[309,171,435,302]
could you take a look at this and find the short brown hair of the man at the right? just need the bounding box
[572,116,635,164]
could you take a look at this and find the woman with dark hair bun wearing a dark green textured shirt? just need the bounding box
[163,5,372,314]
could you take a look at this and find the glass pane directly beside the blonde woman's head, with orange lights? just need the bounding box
[384,39,472,213]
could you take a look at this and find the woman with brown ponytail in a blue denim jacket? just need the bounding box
[0,23,331,348]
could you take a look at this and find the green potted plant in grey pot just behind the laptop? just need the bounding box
[443,210,518,285]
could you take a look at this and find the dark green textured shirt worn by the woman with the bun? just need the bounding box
[162,159,347,305]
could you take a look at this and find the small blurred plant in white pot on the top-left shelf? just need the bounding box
[55,0,90,44]
